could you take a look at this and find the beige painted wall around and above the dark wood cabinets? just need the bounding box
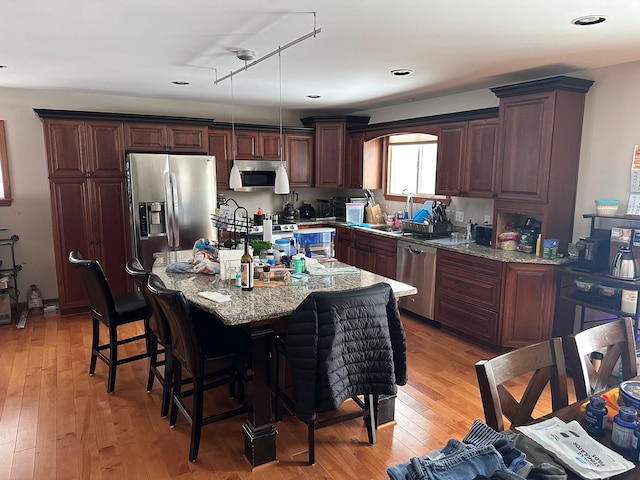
[0,62,640,301]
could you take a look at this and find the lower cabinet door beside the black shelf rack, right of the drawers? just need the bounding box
[500,263,556,348]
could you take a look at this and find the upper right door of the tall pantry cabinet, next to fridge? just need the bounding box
[86,122,125,177]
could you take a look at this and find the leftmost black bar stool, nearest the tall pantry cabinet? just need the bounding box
[69,251,151,393]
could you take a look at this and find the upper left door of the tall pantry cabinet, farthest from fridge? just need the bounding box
[44,120,87,177]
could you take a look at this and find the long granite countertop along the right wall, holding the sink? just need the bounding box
[298,219,575,265]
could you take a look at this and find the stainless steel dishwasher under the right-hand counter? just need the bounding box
[396,240,437,320]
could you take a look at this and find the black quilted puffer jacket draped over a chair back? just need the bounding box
[286,283,407,421]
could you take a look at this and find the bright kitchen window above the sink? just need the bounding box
[385,133,443,200]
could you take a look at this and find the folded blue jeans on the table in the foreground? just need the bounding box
[387,439,523,480]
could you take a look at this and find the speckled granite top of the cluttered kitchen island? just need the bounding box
[153,250,418,326]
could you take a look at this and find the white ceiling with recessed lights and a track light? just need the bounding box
[0,0,640,113]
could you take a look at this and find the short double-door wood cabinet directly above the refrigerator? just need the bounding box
[125,123,208,154]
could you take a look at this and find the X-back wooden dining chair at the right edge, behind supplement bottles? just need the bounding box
[565,317,638,400]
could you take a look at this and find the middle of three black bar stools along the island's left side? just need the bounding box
[125,257,173,418]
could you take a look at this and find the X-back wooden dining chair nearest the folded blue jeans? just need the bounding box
[476,338,569,432]
